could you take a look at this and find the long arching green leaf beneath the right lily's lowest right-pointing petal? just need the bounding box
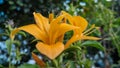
[81,41,105,51]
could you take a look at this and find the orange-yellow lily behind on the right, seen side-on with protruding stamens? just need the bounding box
[61,11,100,49]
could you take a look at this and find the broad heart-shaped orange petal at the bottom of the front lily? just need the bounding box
[36,42,64,59]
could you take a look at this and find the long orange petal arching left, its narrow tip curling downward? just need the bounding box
[10,24,48,43]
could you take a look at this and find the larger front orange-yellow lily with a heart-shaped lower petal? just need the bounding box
[10,12,78,59]
